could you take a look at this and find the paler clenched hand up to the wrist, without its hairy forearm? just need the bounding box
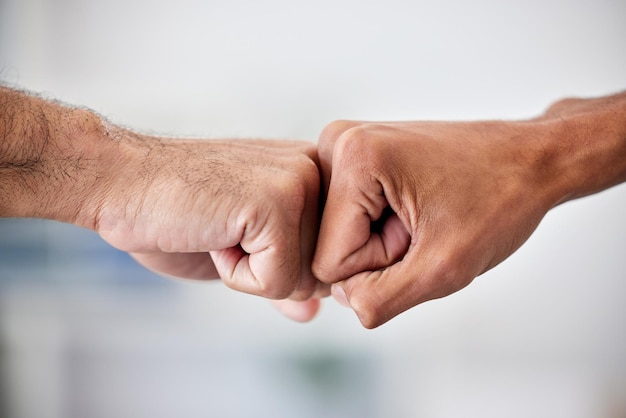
[96,132,328,306]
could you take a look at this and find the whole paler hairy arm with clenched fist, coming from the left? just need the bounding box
[0,86,328,320]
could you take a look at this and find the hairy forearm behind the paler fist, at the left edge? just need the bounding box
[0,86,115,227]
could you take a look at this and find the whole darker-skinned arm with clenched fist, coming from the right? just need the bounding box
[313,93,626,328]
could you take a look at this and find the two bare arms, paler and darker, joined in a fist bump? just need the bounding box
[0,86,626,328]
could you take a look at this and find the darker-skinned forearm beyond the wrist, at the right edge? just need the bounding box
[542,92,626,204]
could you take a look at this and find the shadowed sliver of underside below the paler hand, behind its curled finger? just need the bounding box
[130,253,219,280]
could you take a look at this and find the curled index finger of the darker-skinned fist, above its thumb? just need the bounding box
[313,134,410,283]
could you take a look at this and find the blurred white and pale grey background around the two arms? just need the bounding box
[0,0,626,418]
